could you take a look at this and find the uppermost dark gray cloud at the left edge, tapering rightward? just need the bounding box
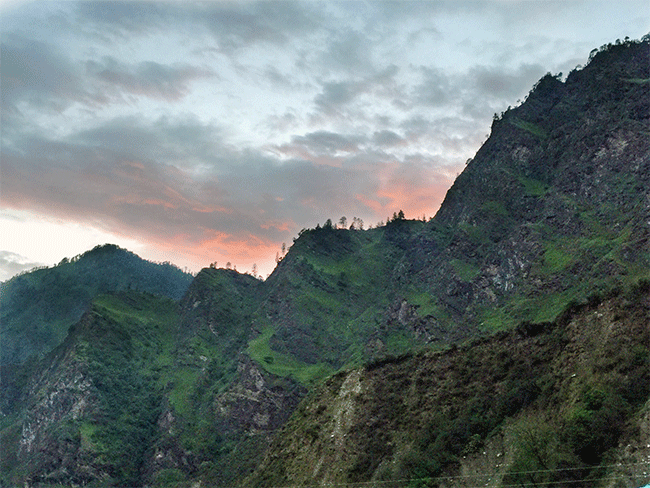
[0,34,210,128]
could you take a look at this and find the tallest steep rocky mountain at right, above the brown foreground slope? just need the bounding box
[403,37,650,333]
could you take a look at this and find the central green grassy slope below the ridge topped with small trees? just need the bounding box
[247,220,424,385]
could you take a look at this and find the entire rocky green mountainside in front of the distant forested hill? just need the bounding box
[0,39,650,487]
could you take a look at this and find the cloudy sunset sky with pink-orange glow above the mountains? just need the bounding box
[0,0,650,281]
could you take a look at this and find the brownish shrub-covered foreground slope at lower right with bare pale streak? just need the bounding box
[247,282,650,488]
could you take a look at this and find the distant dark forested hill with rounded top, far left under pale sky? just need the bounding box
[0,244,192,365]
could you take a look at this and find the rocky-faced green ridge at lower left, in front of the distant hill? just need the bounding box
[2,292,178,486]
